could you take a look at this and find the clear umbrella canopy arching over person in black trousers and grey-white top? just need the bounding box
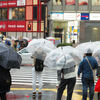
[44,46,83,67]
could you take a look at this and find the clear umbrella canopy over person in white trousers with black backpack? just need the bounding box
[27,39,56,60]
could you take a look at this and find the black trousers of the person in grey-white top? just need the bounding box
[57,77,76,100]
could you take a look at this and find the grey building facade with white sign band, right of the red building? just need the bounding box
[48,0,100,43]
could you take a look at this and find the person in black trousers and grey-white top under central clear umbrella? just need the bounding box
[56,55,76,100]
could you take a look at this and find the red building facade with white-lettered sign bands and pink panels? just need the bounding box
[0,0,47,39]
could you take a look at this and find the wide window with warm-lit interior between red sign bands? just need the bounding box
[9,7,25,20]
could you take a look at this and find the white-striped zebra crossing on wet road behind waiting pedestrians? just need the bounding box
[11,66,97,85]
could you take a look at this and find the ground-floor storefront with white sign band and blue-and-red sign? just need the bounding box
[51,13,100,43]
